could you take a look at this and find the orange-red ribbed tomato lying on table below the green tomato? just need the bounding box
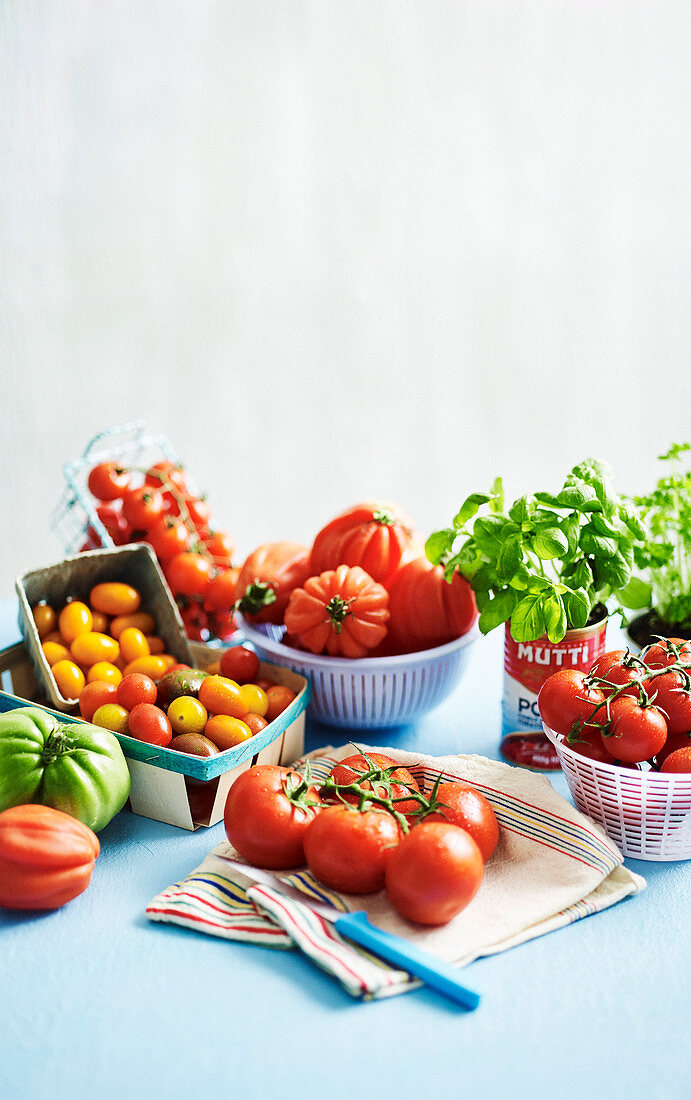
[0,805,100,909]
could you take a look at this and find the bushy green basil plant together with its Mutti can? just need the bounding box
[425,459,644,769]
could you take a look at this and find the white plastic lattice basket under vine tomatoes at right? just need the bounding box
[544,726,691,862]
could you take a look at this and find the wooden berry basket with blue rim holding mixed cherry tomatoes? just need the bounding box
[0,642,310,829]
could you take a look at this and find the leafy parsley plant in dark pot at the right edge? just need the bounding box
[622,443,691,648]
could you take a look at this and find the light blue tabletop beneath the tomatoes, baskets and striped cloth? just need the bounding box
[0,600,691,1100]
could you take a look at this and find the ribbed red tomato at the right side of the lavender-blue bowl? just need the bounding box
[385,558,478,653]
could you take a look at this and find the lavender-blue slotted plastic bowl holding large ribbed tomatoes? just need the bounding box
[238,615,479,729]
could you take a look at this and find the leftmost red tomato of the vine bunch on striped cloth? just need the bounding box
[223,765,321,870]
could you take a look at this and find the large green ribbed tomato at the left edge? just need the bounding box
[0,706,130,833]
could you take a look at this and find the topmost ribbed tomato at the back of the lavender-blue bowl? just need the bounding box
[309,504,412,582]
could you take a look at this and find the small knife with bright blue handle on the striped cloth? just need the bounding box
[220,856,480,1012]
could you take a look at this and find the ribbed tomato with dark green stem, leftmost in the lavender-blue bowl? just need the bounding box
[235,541,311,624]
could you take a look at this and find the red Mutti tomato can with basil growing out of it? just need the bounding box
[501,617,607,771]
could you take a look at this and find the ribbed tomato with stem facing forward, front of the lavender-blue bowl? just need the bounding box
[285,565,388,658]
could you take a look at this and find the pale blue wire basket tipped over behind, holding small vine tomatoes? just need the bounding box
[51,420,179,553]
